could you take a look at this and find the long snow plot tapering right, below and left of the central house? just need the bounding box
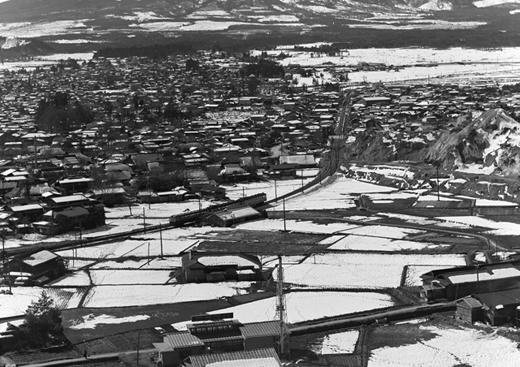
[83,282,251,307]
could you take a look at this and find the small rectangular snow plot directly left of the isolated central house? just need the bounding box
[90,270,176,285]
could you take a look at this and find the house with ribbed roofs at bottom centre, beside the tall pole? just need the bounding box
[154,313,288,367]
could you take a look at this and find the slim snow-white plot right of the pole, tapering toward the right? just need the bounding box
[328,235,442,251]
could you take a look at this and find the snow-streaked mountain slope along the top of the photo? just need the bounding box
[0,0,520,52]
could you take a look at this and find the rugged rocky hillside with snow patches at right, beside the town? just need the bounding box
[346,109,520,177]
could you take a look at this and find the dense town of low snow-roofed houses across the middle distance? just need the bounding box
[0,53,520,234]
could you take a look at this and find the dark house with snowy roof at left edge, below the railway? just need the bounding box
[6,250,65,285]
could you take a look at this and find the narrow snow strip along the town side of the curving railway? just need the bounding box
[223,178,312,200]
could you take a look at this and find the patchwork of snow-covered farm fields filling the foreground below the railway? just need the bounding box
[5,166,514,367]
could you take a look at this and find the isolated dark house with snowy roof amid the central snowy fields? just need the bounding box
[182,251,269,283]
